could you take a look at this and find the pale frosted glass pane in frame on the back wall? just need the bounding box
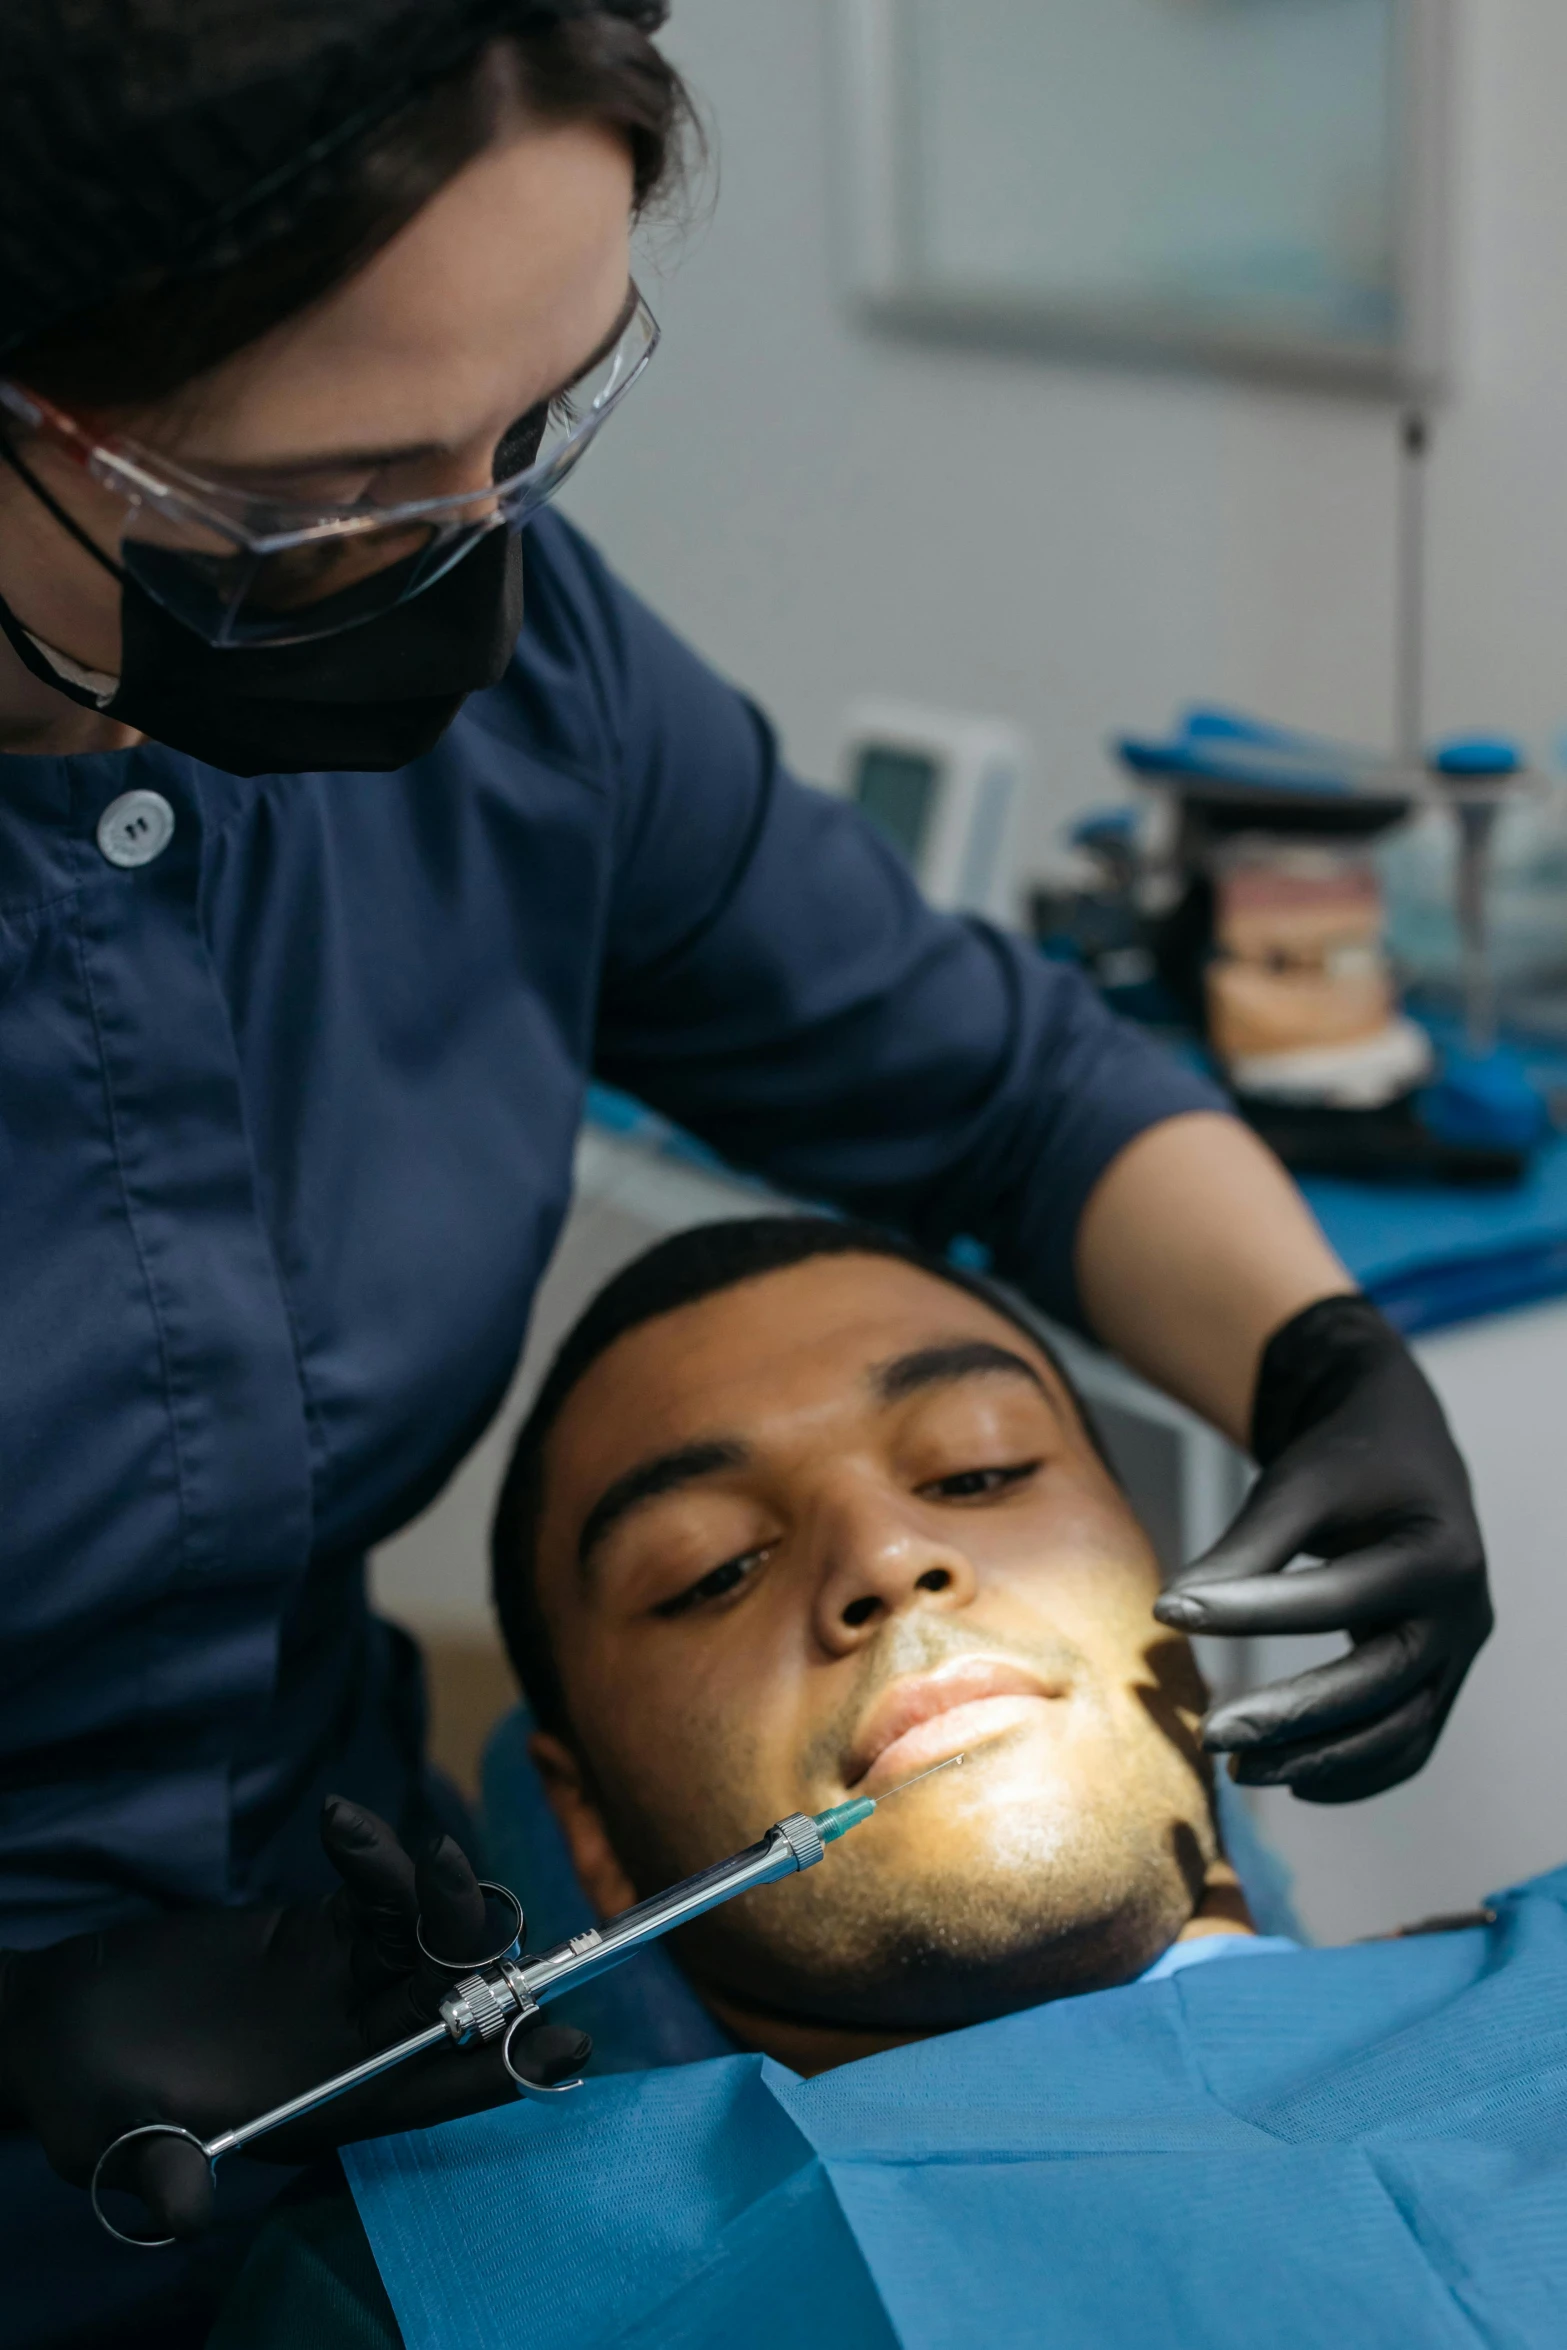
[843,0,1447,394]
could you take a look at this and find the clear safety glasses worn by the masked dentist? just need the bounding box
[0,289,658,646]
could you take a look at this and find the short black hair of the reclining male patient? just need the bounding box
[491,1215,1107,1737]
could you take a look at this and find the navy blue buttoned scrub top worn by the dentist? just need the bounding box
[0,517,1212,1948]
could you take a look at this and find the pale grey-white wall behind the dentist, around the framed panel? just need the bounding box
[571,0,1567,860]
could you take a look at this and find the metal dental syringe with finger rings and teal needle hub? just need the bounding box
[92,1755,963,2249]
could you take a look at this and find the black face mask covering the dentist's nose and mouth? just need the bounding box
[0,449,522,776]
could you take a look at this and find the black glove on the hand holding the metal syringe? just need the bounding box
[0,1798,590,2237]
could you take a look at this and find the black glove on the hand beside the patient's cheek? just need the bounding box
[1154,1297,1494,1802]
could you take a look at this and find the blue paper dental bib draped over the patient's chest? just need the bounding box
[345,1871,1567,2350]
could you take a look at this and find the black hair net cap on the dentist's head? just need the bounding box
[0,0,667,357]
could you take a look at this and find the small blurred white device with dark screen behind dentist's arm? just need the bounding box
[841,703,1029,924]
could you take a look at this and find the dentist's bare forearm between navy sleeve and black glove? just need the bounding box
[1076,1114,1356,1445]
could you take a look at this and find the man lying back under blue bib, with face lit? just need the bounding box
[214,1217,1567,2350]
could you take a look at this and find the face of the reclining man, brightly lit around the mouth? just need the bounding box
[526,1257,1215,2028]
